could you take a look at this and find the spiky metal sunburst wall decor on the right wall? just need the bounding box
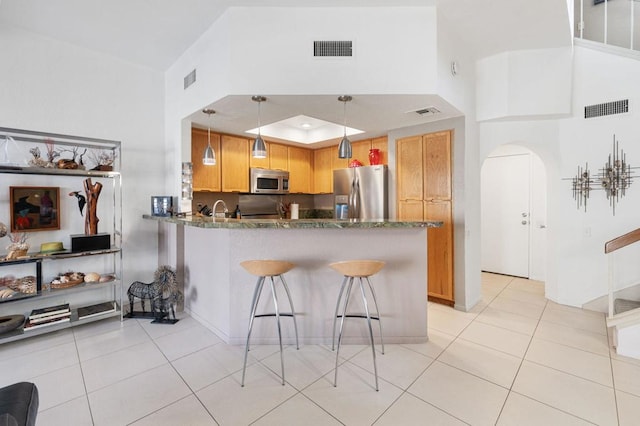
[571,135,637,216]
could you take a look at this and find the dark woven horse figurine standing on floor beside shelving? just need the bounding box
[127,265,180,318]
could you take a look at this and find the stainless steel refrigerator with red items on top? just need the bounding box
[333,165,389,220]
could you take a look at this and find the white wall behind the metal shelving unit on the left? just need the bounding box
[0,26,164,281]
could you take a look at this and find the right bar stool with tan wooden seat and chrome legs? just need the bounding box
[329,260,384,391]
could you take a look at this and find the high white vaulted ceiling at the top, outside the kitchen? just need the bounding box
[0,0,571,70]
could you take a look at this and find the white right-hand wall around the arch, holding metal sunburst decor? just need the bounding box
[480,47,640,306]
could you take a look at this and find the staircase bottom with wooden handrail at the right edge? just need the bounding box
[604,228,640,359]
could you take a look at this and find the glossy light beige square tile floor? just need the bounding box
[0,274,640,426]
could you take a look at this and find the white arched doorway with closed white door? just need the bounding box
[480,144,547,281]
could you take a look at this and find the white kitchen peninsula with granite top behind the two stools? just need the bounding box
[144,215,441,344]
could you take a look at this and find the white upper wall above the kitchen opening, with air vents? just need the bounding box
[166,7,436,193]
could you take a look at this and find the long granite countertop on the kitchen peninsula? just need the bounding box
[142,214,442,229]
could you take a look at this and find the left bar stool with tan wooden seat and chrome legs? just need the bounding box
[240,260,300,387]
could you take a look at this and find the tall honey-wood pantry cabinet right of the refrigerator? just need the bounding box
[396,131,454,306]
